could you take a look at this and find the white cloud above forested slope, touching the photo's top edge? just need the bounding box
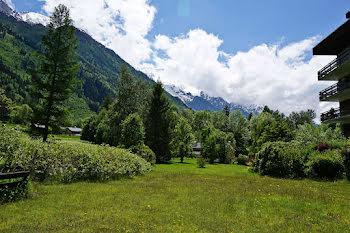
[39,0,156,68]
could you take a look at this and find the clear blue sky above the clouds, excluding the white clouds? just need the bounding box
[12,0,350,53]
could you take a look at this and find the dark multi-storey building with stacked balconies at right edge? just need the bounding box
[313,12,350,137]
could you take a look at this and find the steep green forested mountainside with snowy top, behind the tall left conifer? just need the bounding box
[0,0,186,122]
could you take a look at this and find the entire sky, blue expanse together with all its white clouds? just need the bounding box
[7,0,350,117]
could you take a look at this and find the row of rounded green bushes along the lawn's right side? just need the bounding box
[254,142,350,180]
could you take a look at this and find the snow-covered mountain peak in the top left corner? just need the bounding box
[0,0,50,26]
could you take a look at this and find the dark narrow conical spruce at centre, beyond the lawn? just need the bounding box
[146,81,171,163]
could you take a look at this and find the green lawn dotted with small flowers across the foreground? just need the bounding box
[0,159,350,232]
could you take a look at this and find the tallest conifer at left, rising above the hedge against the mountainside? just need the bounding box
[32,4,79,142]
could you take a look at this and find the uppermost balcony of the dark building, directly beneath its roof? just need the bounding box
[318,50,350,80]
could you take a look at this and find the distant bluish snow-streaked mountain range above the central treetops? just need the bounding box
[165,85,263,117]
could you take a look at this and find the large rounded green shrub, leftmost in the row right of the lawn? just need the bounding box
[255,142,304,178]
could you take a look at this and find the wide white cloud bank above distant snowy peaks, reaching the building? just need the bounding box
[143,29,332,120]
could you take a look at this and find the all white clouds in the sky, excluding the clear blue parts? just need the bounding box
[36,0,332,120]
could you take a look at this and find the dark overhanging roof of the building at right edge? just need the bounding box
[313,12,350,55]
